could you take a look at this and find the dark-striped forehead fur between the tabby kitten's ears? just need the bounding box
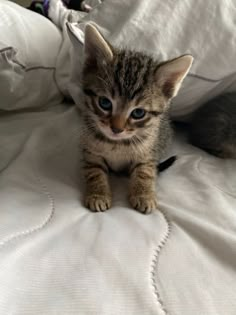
[114,51,153,100]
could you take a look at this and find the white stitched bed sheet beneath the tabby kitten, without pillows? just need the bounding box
[0,106,236,315]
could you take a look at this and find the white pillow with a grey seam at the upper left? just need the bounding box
[0,0,62,110]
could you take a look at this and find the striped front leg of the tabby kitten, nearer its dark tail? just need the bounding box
[129,162,157,213]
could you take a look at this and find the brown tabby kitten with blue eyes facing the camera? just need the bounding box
[77,24,193,213]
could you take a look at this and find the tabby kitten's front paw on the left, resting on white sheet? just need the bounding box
[85,195,111,212]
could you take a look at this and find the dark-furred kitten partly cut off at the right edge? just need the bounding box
[189,93,236,159]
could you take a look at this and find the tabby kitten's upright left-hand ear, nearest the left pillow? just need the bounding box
[84,24,113,64]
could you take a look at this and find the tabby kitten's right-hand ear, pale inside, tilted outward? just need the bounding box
[156,55,193,98]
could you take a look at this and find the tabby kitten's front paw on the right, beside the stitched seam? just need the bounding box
[129,195,157,214]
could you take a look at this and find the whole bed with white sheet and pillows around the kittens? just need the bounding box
[0,0,236,315]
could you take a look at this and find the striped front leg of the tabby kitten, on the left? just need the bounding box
[84,162,111,211]
